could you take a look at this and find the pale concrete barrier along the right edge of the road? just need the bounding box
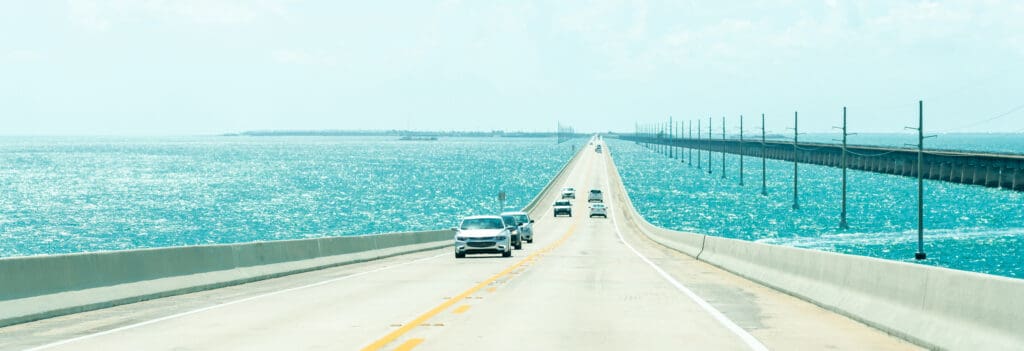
[608,151,1024,350]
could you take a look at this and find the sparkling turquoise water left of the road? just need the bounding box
[0,137,582,257]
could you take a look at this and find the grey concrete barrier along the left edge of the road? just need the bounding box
[0,230,452,326]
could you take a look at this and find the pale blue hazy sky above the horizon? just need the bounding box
[0,0,1024,135]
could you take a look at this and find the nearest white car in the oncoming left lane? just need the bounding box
[452,216,513,258]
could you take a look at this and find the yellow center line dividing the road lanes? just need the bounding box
[361,146,593,351]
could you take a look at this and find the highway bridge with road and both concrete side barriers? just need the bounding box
[0,139,1024,350]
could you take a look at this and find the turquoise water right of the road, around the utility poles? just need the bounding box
[608,135,1024,277]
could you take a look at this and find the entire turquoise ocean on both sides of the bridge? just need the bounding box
[0,134,1024,278]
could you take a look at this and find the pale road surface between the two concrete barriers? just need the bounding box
[0,139,919,351]
